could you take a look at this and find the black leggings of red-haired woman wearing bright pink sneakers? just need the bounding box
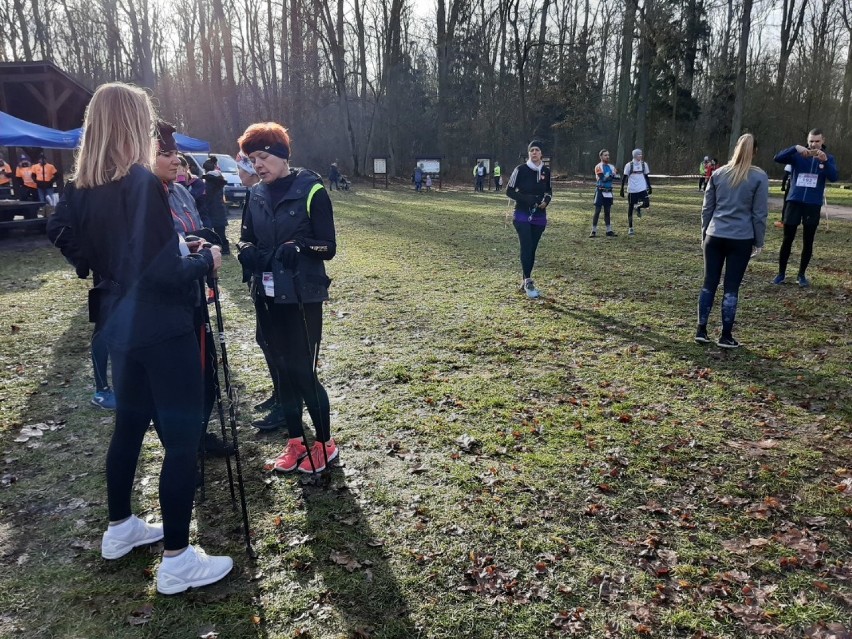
[255,296,331,442]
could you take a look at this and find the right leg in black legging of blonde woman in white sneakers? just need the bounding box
[143,333,203,551]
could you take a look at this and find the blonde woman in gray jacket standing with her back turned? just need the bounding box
[695,133,769,348]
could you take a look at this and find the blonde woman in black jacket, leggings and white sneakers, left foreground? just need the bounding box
[48,83,233,594]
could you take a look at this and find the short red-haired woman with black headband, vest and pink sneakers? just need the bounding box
[238,122,338,473]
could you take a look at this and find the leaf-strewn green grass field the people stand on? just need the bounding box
[0,185,852,639]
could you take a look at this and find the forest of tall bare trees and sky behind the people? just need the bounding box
[0,0,852,179]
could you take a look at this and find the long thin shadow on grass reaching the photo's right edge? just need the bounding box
[545,301,852,419]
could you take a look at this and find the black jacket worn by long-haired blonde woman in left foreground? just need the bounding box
[47,165,213,350]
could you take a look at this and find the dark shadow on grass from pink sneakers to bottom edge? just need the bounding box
[304,471,419,639]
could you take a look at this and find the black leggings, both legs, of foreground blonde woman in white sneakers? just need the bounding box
[106,333,203,550]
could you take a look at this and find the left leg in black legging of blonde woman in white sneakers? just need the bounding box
[106,350,155,522]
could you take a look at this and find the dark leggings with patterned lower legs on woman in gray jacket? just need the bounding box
[698,235,754,337]
